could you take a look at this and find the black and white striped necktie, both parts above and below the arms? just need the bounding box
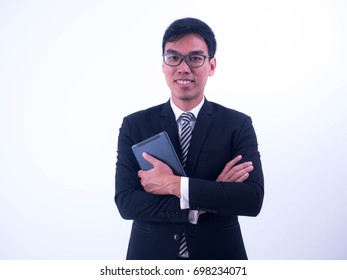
[178,112,194,258]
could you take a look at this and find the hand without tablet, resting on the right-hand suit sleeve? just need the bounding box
[216,155,254,183]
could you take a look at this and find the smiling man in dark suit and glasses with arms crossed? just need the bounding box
[115,18,264,259]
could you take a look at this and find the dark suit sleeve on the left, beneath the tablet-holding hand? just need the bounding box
[115,118,189,223]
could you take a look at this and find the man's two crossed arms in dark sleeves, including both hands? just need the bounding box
[115,112,264,223]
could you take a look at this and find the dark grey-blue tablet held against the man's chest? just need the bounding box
[131,131,186,176]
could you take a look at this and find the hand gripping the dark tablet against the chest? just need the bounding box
[137,153,181,197]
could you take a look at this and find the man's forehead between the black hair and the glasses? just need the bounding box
[165,34,208,54]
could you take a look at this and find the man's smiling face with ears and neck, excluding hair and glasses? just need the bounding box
[162,34,216,110]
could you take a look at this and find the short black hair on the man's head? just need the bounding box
[162,18,217,58]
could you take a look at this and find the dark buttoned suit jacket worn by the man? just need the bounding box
[115,100,264,259]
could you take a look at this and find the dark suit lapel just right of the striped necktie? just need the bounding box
[186,100,213,176]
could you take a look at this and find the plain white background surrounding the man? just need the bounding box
[0,0,347,259]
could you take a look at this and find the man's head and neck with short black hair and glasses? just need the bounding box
[162,18,216,111]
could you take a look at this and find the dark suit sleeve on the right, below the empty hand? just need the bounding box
[189,117,264,216]
